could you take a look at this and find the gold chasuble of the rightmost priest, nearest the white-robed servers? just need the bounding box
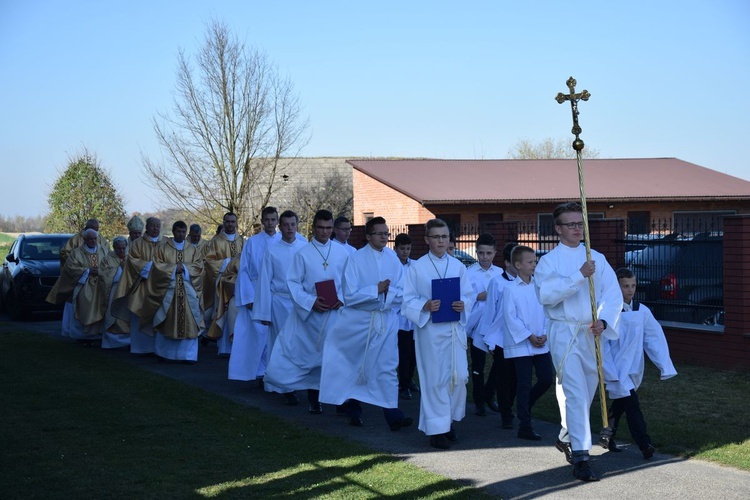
[203,232,244,338]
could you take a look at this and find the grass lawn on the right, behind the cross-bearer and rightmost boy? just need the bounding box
[468,350,750,471]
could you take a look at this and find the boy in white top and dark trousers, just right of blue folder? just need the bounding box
[466,233,503,417]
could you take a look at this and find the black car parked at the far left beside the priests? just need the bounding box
[0,234,72,320]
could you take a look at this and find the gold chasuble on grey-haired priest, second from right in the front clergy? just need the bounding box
[112,235,164,328]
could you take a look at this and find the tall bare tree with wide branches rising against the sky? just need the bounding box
[141,21,308,234]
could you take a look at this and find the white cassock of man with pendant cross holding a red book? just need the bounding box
[264,239,347,392]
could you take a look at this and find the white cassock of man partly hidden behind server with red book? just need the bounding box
[254,239,307,392]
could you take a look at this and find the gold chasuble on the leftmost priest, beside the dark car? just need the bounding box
[47,245,108,335]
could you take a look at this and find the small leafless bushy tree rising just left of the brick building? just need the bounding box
[290,171,354,237]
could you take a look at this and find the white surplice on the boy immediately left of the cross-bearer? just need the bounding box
[502,276,549,359]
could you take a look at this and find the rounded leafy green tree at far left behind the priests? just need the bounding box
[45,151,126,239]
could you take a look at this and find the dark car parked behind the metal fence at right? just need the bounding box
[628,233,724,325]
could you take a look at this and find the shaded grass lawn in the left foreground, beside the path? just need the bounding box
[0,331,483,499]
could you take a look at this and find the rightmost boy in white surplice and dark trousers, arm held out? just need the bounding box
[599,268,677,459]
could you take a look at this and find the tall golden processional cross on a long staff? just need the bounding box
[555,76,612,437]
